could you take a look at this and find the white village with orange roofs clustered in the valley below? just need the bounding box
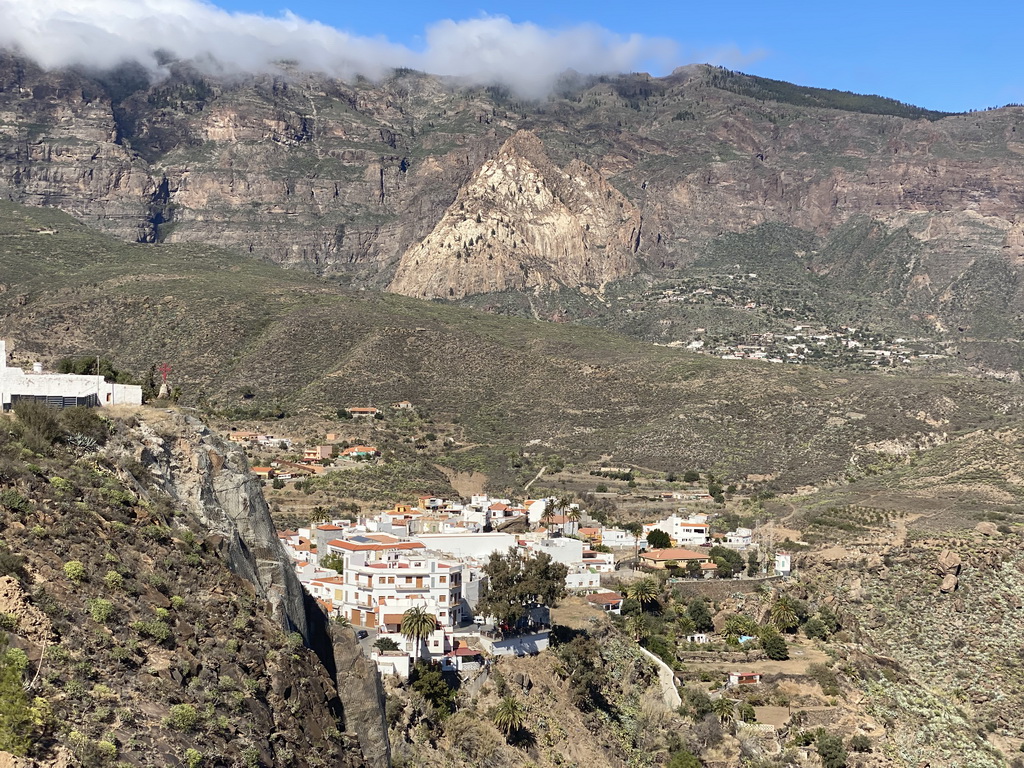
[264,462,792,678]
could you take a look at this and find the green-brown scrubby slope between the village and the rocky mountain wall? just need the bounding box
[0,204,1021,486]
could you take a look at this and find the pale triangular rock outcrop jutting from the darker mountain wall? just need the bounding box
[388,131,642,299]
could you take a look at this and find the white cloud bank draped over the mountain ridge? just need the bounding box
[0,0,761,96]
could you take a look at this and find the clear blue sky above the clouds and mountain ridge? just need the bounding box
[214,0,1024,111]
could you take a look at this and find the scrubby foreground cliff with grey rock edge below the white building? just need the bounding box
[0,411,390,768]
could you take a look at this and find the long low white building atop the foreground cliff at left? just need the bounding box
[0,341,142,411]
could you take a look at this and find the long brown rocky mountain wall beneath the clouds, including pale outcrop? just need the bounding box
[0,56,1024,315]
